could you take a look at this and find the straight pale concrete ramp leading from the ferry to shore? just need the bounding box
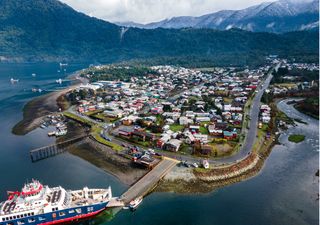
[120,158,178,204]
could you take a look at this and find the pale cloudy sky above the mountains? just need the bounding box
[60,0,274,23]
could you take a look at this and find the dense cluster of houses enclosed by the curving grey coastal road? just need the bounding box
[63,65,276,162]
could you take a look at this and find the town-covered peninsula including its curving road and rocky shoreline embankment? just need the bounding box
[13,58,318,193]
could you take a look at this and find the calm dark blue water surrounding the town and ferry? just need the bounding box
[0,64,319,225]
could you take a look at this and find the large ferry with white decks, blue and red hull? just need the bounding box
[0,180,112,225]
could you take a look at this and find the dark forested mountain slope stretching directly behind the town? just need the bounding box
[0,0,319,65]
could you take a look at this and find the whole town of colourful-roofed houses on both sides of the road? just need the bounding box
[37,57,318,172]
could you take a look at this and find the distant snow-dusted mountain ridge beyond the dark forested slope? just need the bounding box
[117,0,319,33]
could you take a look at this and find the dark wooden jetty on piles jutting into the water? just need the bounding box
[30,135,88,162]
